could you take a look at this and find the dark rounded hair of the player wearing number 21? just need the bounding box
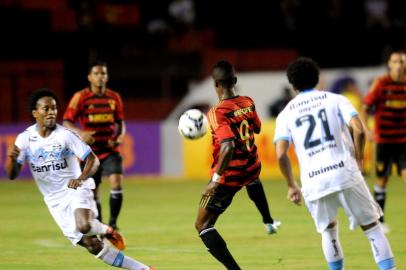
[286,57,319,91]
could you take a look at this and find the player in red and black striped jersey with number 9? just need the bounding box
[195,61,279,270]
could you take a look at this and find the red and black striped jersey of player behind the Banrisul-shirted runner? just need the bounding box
[63,88,124,159]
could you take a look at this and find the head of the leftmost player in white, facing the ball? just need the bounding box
[29,88,58,128]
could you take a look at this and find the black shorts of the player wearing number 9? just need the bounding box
[200,185,241,215]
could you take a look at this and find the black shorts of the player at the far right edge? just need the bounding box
[375,143,406,177]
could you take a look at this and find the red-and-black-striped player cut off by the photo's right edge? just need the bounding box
[361,51,406,232]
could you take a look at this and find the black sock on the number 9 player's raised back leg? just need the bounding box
[246,180,273,224]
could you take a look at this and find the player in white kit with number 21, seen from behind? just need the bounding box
[274,57,396,270]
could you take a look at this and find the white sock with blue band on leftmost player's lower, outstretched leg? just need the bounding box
[96,245,150,270]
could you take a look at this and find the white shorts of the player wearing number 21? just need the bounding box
[306,181,383,233]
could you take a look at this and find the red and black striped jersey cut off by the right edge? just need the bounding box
[364,75,406,143]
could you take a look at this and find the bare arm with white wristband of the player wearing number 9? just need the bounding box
[203,141,235,196]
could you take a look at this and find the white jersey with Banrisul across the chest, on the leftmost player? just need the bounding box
[15,124,95,205]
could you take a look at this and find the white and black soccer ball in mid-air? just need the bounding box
[178,109,208,140]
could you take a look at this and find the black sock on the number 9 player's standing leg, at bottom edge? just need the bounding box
[200,227,241,270]
